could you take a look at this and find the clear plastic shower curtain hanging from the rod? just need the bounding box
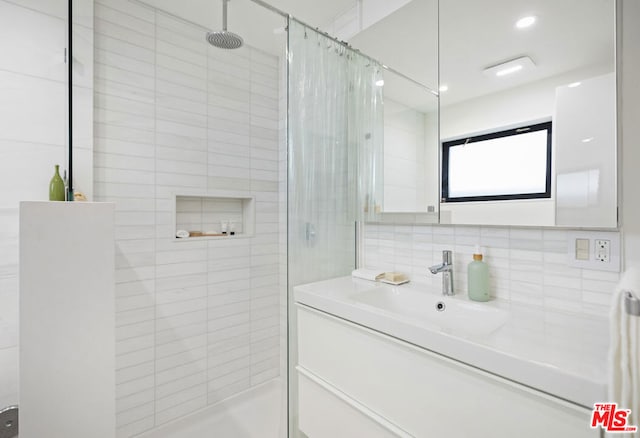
[288,20,383,286]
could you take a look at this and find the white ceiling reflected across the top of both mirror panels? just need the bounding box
[350,0,615,106]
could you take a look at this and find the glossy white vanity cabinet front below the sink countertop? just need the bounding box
[297,304,600,438]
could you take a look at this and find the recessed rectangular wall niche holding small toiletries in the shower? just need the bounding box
[173,195,255,241]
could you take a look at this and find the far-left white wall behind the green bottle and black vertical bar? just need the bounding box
[0,0,93,408]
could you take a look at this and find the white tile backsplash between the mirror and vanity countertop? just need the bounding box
[364,224,619,318]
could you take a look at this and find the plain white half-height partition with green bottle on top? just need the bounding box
[20,202,115,438]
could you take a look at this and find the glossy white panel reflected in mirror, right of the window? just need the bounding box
[554,73,618,227]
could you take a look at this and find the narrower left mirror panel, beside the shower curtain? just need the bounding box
[349,0,439,219]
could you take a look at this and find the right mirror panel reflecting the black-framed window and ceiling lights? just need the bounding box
[440,0,617,227]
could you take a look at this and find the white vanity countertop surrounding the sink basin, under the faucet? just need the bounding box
[294,277,609,408]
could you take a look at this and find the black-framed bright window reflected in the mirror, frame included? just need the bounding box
[442,122,551,202]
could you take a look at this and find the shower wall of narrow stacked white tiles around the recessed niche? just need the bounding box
[95,0,284,437]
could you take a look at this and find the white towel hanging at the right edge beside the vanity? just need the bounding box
[609,268,640,437]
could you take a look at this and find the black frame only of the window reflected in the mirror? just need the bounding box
[441,121,553,203]
